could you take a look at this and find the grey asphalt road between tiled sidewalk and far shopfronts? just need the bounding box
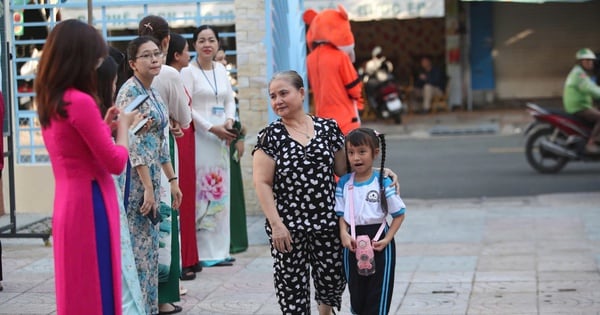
[386,135,600,199]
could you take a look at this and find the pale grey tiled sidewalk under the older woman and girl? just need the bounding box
[0,192,600,315]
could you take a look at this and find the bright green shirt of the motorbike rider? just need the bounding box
[563,65,600,114]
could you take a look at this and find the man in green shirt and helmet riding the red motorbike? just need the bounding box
[563,48,600,154]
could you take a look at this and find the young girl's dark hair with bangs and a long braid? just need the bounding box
[346,128,388,212]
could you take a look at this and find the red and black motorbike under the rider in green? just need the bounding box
[525,103,600,174]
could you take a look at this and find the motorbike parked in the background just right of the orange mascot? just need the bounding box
[365,70,404,124]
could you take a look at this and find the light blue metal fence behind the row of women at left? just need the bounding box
[5,0,236,164]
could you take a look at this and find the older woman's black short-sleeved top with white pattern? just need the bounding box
[253,116,344,231]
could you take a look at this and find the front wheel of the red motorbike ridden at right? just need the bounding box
[525,126,569,174]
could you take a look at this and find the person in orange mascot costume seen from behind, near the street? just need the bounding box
[303,5,363,134]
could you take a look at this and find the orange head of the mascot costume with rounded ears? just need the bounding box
[302,4,355,62]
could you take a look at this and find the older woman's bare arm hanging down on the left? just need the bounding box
[252,150,292,253]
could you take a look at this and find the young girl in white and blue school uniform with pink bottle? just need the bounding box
[335,128,405,315]
